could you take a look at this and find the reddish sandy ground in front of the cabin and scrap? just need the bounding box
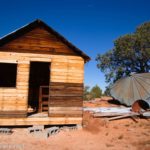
[0,98,150,150]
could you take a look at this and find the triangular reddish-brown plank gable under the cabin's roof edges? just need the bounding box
[2,27,77,55]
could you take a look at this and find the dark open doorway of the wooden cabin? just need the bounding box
[28,62,50,113]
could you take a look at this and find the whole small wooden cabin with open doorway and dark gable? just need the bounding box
[0,20,90,126]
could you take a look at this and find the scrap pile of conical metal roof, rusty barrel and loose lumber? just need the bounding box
[102,73,150,120]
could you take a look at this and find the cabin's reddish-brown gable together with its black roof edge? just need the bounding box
[0,20,90,61]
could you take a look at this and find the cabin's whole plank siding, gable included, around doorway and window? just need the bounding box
[0,28,84,120]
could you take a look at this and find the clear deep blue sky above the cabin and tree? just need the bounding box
[0,0,150,90]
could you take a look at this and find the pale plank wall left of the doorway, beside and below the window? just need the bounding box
[0,62,29,117]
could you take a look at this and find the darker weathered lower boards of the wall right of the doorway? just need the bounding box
[49,82,83,117]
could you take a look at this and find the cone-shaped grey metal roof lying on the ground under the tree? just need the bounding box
[110,73,150,106]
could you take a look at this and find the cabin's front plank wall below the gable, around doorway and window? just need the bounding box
[0,52,84,120]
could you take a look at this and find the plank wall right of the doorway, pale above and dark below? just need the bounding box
[49,57,84,117]
